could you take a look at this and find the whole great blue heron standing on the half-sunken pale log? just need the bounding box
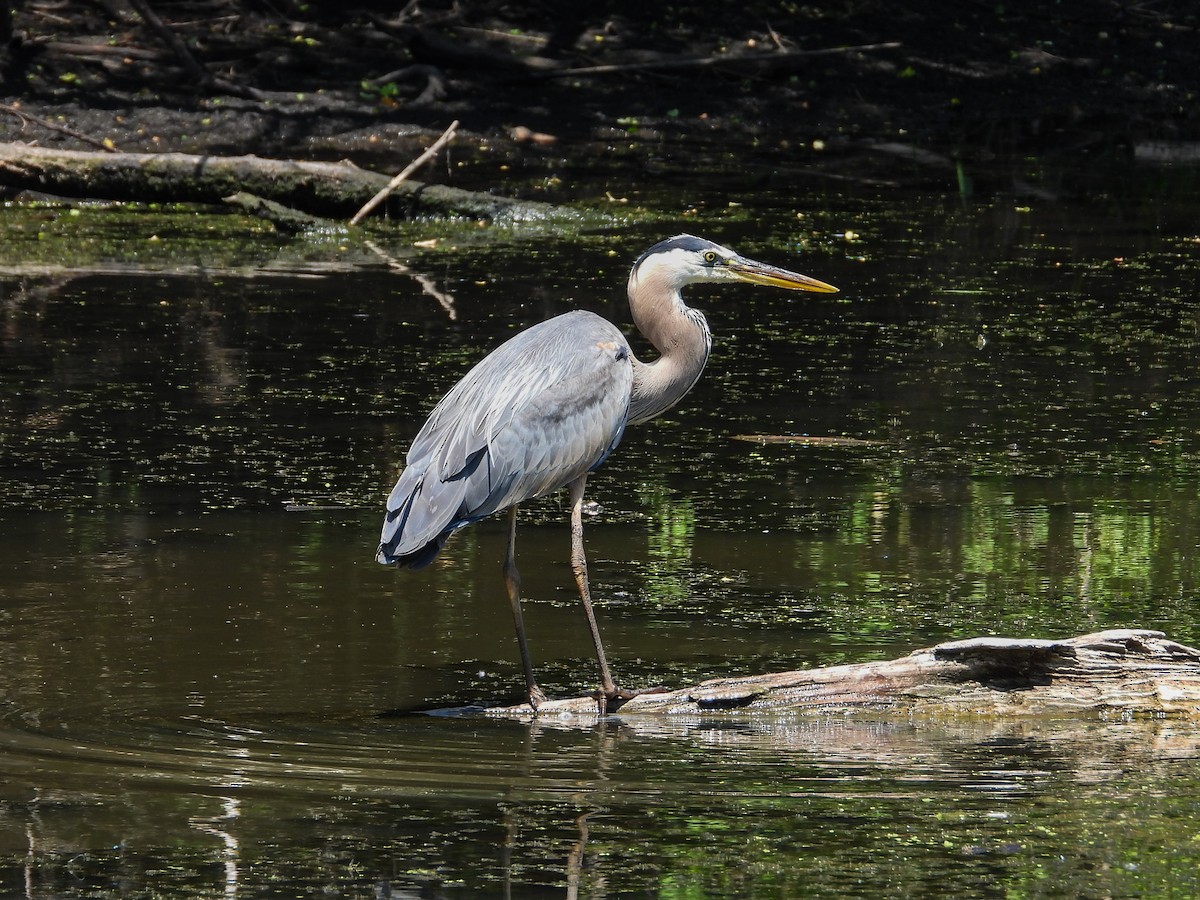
[376,234,838,709]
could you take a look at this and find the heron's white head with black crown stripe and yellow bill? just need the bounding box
[630,234,838,294]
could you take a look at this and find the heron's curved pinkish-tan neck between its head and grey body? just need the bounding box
[629,271,713,425]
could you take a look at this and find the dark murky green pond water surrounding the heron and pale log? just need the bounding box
[0,165,1200,898]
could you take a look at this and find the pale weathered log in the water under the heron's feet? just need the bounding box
[487,629,1200,721]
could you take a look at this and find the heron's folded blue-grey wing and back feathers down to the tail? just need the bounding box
[377,312,632,568]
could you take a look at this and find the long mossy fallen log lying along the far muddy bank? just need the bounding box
[0,143,577,223]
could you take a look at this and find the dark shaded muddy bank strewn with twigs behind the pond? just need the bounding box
[0,0,1200,190]
